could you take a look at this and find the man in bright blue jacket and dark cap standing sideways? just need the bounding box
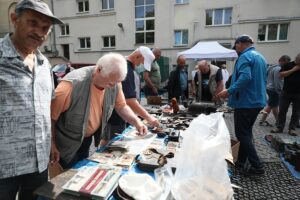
[217,35,267,175]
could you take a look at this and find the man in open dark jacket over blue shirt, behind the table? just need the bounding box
[168,56,189,100]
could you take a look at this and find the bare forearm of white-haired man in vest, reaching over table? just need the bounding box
[115,105,147,135]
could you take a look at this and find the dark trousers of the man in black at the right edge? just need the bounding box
[277,91,300,130]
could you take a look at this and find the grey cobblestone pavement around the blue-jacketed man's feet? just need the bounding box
[224,110,300,200]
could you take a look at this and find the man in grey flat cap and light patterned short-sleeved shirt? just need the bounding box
[0,0,63,200]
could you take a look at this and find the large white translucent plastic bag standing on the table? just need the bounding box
[171,113,233,200]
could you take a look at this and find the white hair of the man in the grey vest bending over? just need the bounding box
[97,53,127,80]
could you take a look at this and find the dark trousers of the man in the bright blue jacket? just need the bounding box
[234,108,263,168]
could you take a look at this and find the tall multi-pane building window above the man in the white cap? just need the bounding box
[135,0,155,44]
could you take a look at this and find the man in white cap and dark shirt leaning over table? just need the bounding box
[101,46,159,145]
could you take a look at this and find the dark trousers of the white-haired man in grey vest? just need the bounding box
[59,136,93,169]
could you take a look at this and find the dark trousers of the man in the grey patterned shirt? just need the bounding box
[0,169,48,200]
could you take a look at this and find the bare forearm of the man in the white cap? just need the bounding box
[126,98,159,127]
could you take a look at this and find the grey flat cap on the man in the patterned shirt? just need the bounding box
[15,0,64,24]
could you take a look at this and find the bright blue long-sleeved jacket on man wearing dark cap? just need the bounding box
[228,47,267,108]
